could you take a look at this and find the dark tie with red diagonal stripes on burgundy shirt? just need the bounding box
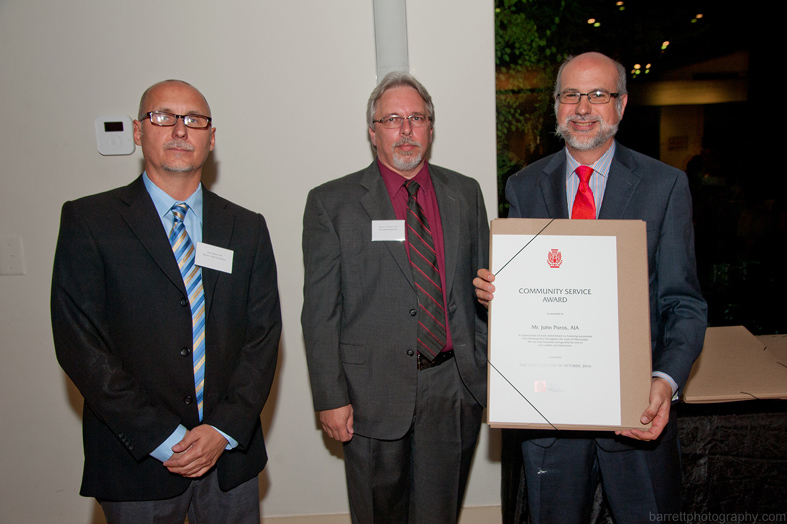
[404,180,446,360]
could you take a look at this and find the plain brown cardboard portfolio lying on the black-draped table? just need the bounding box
[683,326,787,404]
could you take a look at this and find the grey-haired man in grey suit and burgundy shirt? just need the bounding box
[301,72,489,524]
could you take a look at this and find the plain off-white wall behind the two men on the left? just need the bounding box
[0,0,500,524]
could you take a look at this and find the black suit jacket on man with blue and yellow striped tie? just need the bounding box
[51,177,281,500]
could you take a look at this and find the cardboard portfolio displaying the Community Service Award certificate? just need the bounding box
[487,219,651,430]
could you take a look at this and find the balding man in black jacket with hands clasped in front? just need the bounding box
[51,80,281,524]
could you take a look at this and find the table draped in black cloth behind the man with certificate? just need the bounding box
[501,400,787,524]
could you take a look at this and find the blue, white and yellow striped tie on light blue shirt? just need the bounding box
[169,202,205,421]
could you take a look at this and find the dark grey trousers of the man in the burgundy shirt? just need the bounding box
[344,360,483,524]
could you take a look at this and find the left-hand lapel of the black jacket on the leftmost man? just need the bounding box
[120,176,186,295]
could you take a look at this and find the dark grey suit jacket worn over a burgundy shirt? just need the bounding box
[301,161,489,439]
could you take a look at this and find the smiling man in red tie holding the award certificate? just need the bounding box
[473,53,707,524]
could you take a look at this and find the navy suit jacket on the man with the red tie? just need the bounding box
[506,144,707,450]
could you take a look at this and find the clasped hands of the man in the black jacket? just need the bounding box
[164,424,227,478]
